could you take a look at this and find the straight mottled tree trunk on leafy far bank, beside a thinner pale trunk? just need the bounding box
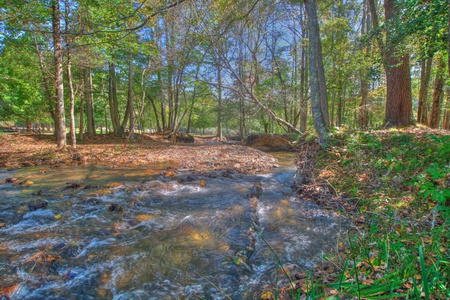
[52,0,66,149]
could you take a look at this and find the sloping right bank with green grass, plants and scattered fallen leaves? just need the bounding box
[286,129,450,299]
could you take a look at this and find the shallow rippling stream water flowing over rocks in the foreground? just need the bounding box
[0,153,343,299]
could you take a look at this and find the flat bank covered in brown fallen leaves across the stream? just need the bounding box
[0,134,278,173]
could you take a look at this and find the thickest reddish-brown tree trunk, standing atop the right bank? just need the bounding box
[384,0,412,126]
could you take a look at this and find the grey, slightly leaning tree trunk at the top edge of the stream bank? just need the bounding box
[305,0,328,147]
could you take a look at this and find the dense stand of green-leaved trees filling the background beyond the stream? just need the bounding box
[0,0,450,147]
